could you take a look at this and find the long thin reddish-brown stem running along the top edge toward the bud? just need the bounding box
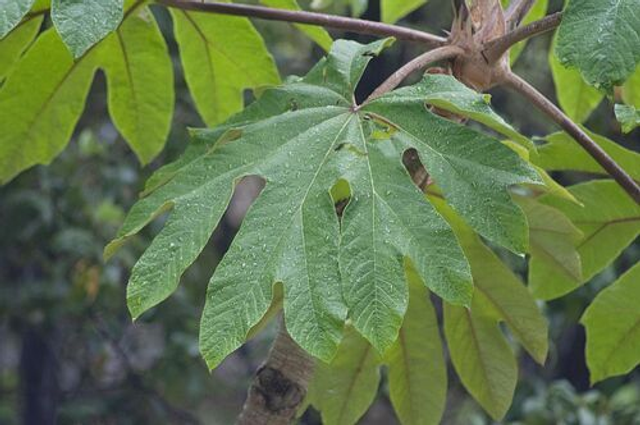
[156,0,447,47]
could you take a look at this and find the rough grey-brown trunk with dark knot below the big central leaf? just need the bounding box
[237,322,315,425]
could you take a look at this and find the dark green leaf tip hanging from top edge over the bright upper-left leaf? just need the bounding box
[51,0,124,58]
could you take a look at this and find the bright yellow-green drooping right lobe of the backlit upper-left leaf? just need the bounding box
[100,9,175,164]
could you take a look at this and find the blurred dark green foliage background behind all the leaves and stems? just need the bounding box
[0,0,640,425]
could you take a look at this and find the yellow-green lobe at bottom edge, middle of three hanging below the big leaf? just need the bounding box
[385,268,447,425]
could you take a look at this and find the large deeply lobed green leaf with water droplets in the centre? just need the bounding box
[107,41,538,367]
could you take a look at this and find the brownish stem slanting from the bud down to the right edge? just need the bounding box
[504,73,640,205]
